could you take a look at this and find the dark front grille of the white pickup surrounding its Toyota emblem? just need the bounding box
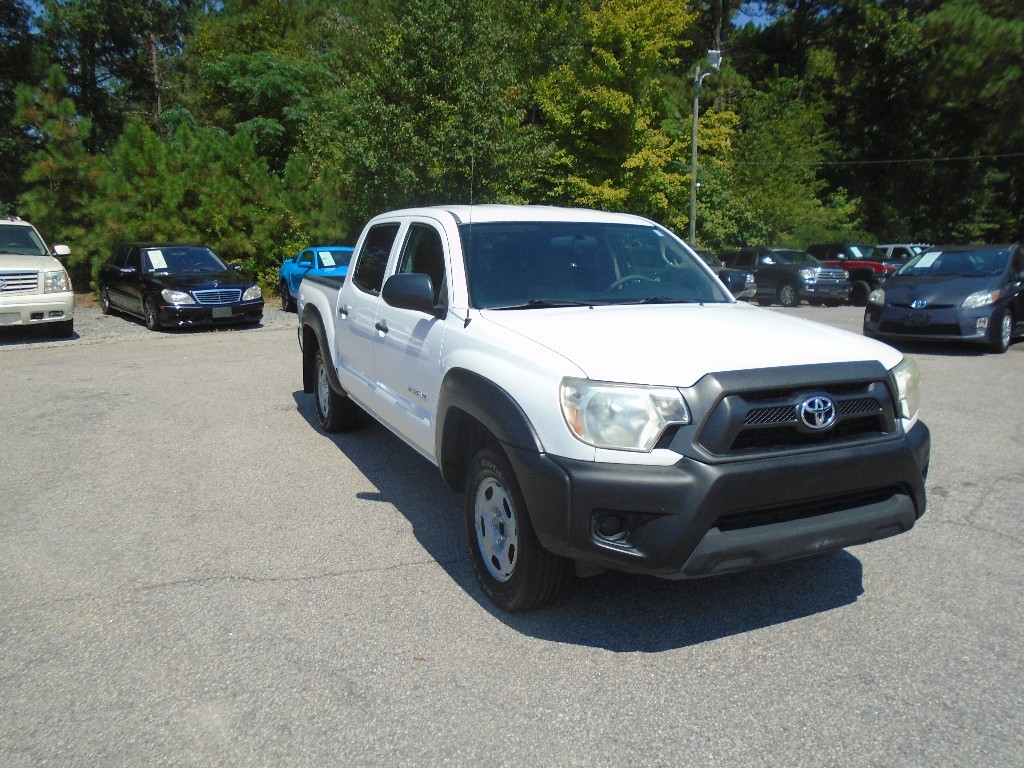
[697,381,898,457]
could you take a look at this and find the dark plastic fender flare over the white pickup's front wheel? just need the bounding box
[434,369,544,490]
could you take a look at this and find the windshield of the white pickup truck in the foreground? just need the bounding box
[460,221,732,309]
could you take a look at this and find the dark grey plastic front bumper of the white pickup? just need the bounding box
[506,423,931,579]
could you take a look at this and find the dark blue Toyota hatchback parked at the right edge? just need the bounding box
[864,244,1024,352]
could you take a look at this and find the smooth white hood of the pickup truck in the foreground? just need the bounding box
[481,303,902,387]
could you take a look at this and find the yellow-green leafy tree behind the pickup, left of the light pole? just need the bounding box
[538,0,692,229]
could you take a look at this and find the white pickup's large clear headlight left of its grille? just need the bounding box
[561,379,690,451]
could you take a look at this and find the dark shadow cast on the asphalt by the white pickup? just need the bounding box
[294,391,863,653]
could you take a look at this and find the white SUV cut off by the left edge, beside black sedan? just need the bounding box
[0,216,75,336]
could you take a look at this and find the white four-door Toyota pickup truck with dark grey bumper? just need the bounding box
[299,206,931,611]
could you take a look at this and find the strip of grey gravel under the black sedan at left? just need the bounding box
[0,294,298,347]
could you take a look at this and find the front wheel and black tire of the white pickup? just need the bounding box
[465,446,569,612]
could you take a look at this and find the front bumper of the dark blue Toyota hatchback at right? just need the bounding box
[864,304,998,343]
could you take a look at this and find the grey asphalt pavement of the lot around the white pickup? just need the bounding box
[0,306,1024,768]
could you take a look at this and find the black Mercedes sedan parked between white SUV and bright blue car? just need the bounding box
[99,243,263,331]
